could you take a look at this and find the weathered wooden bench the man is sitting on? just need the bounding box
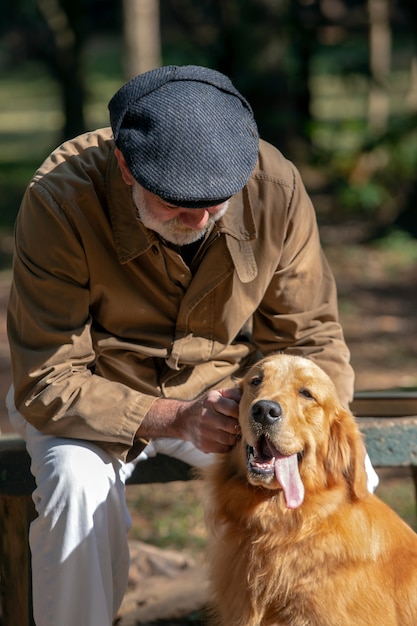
[0,416,417,626]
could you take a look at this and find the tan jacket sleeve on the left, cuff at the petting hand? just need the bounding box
[8,178,155,456]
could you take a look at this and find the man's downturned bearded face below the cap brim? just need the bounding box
[132,181,228,246]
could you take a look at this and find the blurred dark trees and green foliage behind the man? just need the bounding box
[0,0,417,240]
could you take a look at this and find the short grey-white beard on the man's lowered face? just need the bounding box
[132,185,229,246]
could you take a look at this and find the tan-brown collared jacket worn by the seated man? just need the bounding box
[8,129,353,457]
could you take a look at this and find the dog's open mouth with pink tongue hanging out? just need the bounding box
[246,435,304,509]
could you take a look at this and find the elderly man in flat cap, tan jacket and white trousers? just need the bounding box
[8,66,353,626]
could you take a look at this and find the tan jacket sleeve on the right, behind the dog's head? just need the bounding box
[253,158,354,406]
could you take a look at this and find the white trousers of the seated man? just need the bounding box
[7,393,212,626]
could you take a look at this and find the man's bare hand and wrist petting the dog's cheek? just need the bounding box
[136,388,241,453]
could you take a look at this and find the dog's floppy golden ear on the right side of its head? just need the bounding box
[326,406,368,498]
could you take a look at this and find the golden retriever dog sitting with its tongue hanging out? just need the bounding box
[205,354,417,626]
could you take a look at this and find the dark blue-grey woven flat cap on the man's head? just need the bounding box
[109,65,259,208]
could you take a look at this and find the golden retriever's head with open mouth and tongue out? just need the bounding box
[238,354,367,508]
